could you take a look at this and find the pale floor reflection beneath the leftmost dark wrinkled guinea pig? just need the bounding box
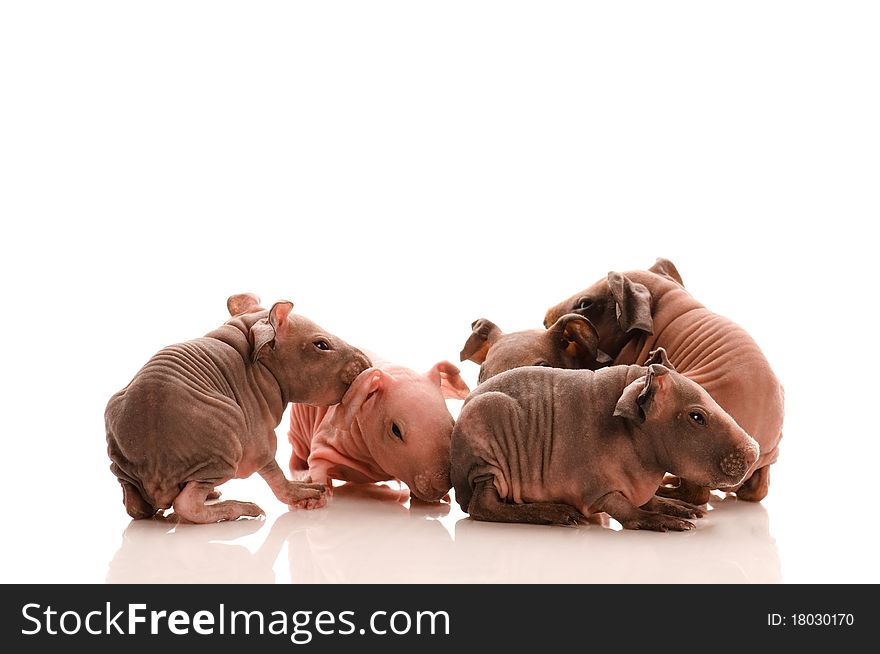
[107,519,283,584]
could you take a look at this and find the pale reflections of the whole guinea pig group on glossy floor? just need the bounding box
[107,486,782,583]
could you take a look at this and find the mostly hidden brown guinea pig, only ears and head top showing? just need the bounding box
[461,313,611,383]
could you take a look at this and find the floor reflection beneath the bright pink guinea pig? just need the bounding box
[288,484,453,583]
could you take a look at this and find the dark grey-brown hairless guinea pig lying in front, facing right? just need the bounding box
[452,349,758,531]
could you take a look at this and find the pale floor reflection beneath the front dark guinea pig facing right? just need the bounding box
[455,497,782,583]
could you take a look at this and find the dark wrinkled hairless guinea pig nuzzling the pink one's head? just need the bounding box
[104,294,370,523]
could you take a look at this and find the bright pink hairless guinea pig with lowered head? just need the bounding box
[288,361,468,502]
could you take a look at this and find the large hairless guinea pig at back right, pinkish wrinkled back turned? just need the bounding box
[544,259,784,504]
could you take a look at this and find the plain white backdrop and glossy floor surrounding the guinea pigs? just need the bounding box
[0,0,880,582]
